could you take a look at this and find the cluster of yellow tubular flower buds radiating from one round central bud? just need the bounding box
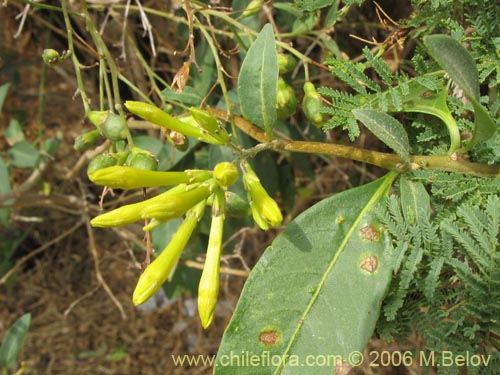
[89,103,283,328]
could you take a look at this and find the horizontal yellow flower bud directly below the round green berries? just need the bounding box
[89,166,210,190]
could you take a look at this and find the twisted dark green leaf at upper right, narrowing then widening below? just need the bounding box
[424,34,496,149]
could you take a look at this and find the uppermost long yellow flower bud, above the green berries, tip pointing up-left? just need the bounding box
[125,100,202,138]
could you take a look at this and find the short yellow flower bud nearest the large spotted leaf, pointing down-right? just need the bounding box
[242,161,283,230]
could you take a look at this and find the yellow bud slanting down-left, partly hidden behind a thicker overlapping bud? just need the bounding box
[90,185,186,228]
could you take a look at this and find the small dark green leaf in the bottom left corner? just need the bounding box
[0,313,31,369]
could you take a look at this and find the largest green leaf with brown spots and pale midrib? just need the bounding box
[214,172,396,375]
